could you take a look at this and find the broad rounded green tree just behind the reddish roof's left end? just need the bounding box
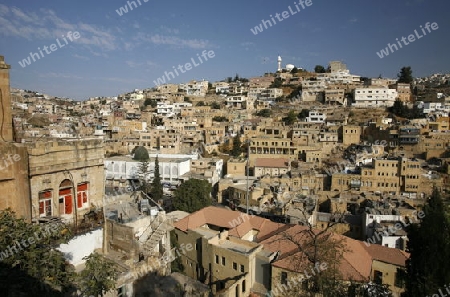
[173,179,212,213]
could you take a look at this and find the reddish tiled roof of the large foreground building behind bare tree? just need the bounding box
[174,206,409,281]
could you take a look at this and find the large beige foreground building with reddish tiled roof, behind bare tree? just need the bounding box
[174,207,409,297]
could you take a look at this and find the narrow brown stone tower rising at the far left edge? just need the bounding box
[0,56,13,142]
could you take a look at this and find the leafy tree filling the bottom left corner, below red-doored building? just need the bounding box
[0,209,75,296]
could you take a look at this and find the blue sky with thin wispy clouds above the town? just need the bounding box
[0,0,450,100]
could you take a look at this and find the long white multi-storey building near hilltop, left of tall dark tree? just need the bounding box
[352,88,398,108]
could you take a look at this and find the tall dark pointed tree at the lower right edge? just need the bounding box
[404,188,450,297]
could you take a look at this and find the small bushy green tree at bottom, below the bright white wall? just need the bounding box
[78,253,118,296]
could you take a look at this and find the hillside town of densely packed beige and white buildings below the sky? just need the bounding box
[0,56,450,297]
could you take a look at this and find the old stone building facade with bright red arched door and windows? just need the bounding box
[27,140,105,225]
